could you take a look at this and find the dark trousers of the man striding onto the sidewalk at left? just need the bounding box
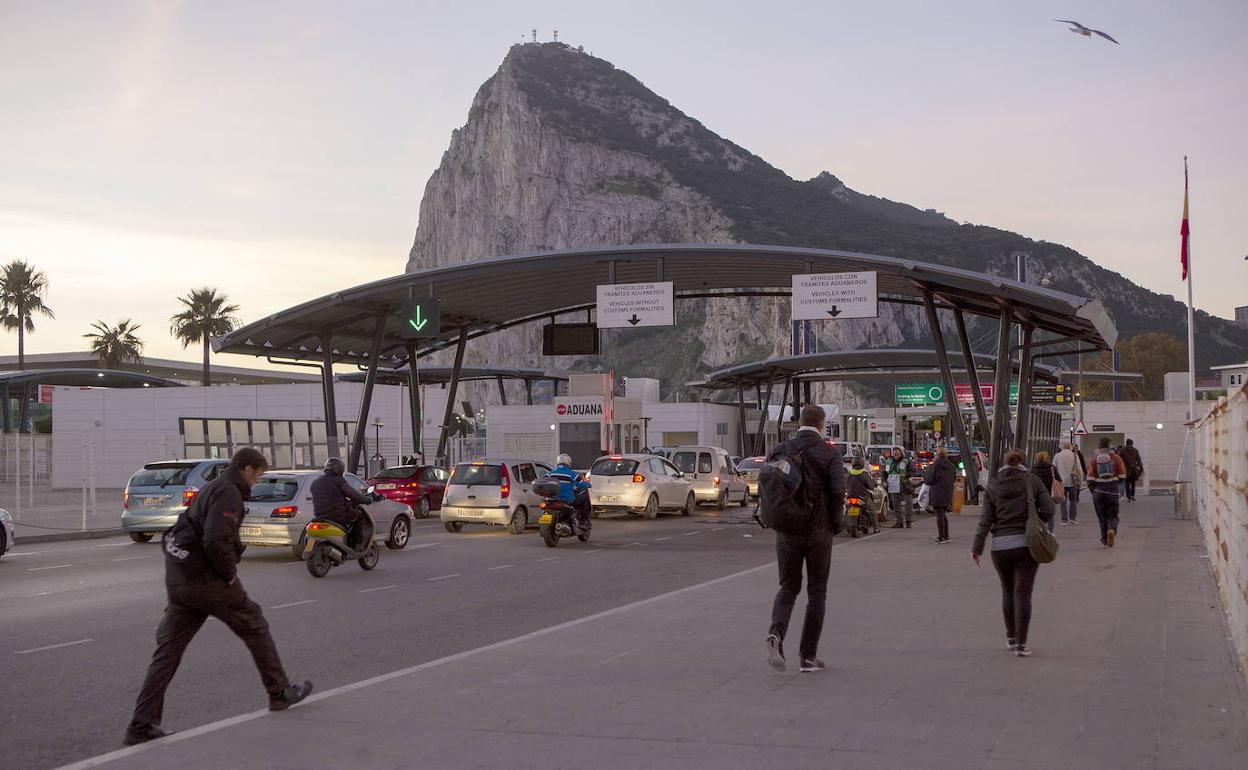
[130,583,290,728]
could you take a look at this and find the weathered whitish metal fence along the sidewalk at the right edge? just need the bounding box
[1194,387,1248,671]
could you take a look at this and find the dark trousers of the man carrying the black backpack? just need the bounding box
[771,527,832,658]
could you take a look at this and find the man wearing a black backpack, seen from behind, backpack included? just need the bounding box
[759,404,845,673]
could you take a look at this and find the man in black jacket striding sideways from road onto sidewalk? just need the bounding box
[125,448,312,746]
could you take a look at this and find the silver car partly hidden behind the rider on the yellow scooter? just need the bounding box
[238,470,413,559]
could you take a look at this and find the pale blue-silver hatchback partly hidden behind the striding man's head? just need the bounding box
[121,459,230,543]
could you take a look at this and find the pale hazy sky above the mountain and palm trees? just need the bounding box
[0,0,1248,366]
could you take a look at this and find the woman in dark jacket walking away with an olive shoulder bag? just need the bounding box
[971,449,1053,658]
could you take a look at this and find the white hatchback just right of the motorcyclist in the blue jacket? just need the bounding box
[589,454,696,519]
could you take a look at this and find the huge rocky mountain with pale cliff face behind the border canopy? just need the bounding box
[407,42,1248,404]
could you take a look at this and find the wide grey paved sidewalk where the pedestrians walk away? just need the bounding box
[70,498,1248,770]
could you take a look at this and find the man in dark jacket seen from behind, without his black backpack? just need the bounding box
[768,404,845,673]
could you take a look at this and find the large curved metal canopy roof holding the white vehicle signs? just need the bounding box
[213,243,1117,367]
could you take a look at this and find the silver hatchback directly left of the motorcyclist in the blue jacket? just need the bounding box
[441,459,550,534]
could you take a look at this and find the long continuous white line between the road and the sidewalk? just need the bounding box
[59,557,776,770]
